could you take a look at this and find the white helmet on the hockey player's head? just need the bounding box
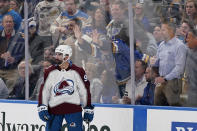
[55,45,72,58]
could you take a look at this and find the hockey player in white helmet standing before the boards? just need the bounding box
[38,45,94,131]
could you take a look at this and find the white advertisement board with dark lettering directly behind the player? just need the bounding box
[0,103,133,131]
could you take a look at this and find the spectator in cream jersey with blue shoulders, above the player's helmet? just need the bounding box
[50,0,92,46]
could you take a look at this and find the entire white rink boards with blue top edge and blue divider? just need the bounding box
[0,100,197,131]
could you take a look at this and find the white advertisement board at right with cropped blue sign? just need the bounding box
[147,109,197,131]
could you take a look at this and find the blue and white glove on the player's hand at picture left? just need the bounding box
[38,105,50,122]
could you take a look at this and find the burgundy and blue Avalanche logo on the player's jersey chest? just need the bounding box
[54,78,74,96]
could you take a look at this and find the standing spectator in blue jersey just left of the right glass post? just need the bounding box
[106,1,130,97]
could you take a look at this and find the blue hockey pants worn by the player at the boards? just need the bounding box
[46,112,83,131]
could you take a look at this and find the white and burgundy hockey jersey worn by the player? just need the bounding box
[39,64,91,114]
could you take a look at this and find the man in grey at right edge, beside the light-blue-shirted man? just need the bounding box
[186,32,197,107]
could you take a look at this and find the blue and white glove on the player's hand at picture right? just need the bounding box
[83,106,94,123]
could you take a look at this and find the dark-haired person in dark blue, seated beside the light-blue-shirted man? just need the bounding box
[135,67,159,105]
